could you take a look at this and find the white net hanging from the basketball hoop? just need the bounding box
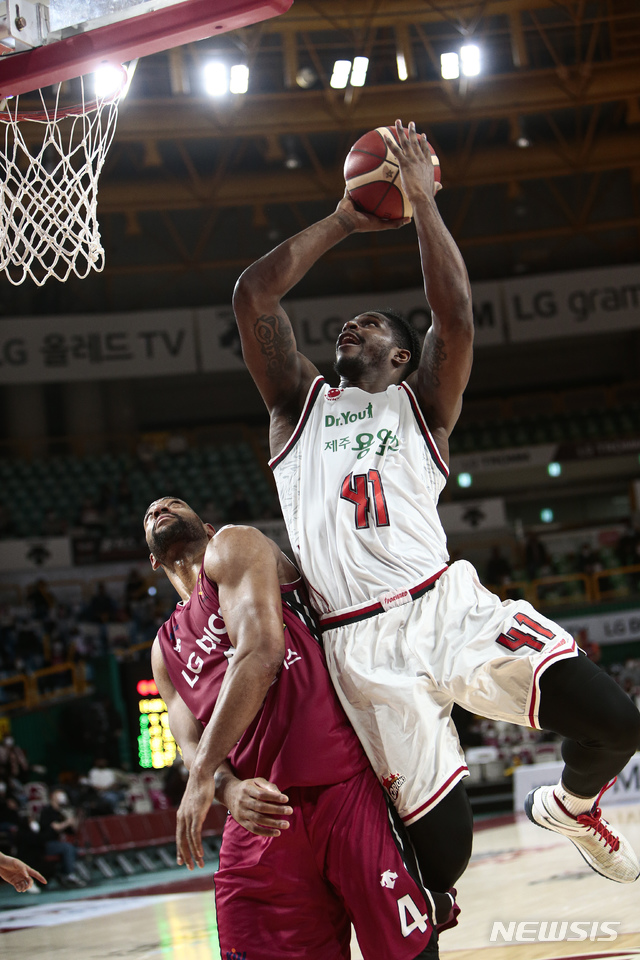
[0,84,120,286]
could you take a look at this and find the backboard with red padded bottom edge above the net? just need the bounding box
[0,0,293,97]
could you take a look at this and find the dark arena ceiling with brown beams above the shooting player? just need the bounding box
[0,0,640,315]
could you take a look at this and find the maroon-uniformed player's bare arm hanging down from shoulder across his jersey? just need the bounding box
[176,527,285,870]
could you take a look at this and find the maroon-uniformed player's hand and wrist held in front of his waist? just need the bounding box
[215,762,293,837]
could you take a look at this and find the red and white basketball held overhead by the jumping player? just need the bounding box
[344,127,440,220]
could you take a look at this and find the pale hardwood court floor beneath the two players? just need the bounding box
[0,805,640,960]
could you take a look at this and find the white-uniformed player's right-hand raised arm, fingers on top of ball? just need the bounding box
[388,121,473,444]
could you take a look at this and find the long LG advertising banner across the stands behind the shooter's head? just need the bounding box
[0,265,640,383]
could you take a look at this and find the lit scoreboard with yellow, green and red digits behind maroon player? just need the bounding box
[120,663,177,770]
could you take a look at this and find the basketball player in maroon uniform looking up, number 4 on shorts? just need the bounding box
[144,498,455,960]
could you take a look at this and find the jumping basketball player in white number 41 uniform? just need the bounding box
[234,121,640,890]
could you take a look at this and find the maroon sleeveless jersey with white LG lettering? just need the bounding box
[158,568,368,790]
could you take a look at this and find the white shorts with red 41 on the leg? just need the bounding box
[324,560,579,824]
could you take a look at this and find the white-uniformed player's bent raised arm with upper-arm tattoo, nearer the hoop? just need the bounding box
[233,197,408,413]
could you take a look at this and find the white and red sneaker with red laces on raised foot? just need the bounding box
[524,780,640,883]
